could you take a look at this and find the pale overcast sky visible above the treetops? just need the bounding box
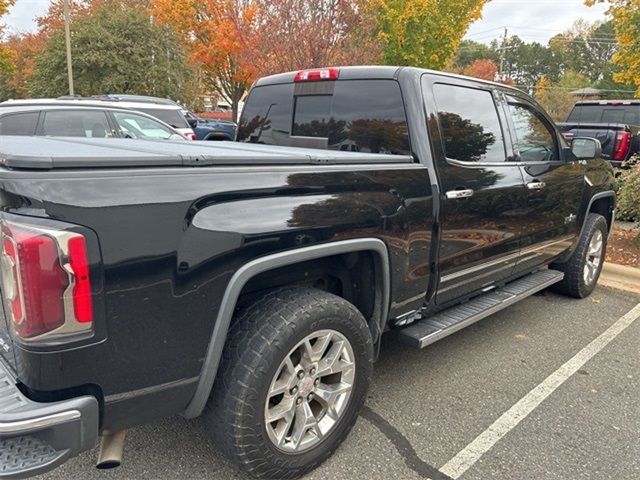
[3,0,607,44]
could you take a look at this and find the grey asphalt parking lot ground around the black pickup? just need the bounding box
[42,288,640,480]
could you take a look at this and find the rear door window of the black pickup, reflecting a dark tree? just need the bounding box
[433,84,506,162]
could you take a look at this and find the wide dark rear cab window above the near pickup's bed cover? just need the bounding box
[237,79,410,155]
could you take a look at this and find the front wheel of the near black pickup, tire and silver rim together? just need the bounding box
[551,213,608,298]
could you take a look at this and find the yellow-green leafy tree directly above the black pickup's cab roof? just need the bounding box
[369,0,488,69]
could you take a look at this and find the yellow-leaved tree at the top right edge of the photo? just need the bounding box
[585,0,640,96]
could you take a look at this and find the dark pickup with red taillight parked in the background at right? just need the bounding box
[558,100,640,167]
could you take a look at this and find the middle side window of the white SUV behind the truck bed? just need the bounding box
[42,110,111,138]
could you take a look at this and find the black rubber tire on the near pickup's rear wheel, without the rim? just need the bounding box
[203,287,373,478]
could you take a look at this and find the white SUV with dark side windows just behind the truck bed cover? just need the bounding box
[0,100,186,140]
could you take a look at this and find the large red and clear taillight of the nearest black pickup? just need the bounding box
[1,222,93,340]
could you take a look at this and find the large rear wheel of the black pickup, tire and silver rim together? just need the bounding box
[205,288,373,478]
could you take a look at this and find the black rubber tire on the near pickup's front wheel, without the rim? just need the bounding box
[551,213,608,298]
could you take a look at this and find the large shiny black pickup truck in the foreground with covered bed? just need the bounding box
[0,67,615,478]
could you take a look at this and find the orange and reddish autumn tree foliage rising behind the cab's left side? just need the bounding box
[151,0,380,119]
